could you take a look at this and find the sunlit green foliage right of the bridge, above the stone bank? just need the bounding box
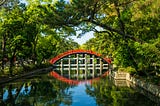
[83,0,160,76]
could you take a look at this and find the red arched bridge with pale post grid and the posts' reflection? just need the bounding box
[50,50,111,80]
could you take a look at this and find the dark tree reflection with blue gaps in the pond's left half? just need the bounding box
[0,76,74,106]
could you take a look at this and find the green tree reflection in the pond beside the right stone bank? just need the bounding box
[86,78,157,106]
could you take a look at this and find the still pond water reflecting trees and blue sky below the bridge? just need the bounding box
[0,71,158,106]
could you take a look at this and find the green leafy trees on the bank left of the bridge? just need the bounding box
[0,1,78,73]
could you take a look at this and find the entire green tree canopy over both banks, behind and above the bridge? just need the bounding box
[0,0,160,78]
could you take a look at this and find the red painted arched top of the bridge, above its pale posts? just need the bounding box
[50,49,111,64]
